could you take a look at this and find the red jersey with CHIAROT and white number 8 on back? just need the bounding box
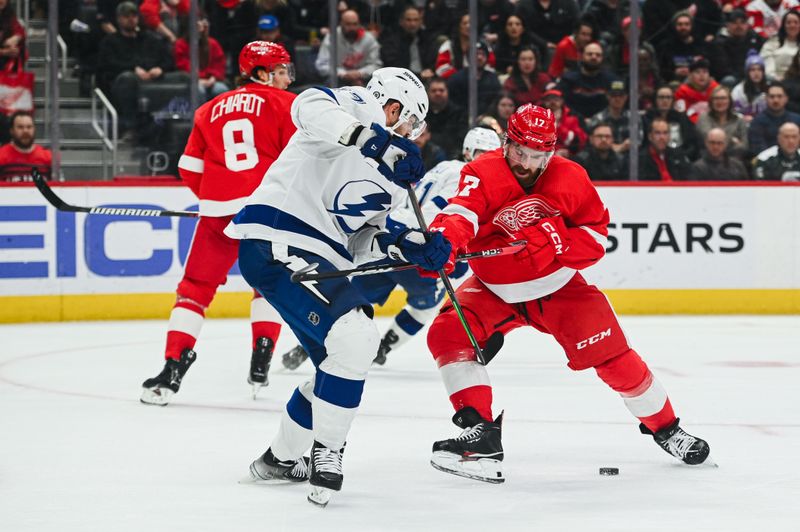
[178,83,297,216]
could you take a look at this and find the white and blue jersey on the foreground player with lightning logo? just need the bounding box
[225,87,406,269]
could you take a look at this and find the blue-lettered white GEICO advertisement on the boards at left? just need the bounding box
[0,186,248,295]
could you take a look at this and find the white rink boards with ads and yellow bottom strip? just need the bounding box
[0,181,800,322]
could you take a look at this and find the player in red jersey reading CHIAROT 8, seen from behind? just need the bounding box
[141,41,296,405]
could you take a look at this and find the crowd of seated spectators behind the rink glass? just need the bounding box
[0,0,800,181]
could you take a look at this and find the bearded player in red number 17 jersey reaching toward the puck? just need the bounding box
[428,104,709,482]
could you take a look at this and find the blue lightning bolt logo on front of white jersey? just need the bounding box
[328,179,392,234]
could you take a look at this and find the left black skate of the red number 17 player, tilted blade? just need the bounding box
[431,406,506,484]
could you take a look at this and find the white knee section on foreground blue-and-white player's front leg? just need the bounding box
[320,308,381,380]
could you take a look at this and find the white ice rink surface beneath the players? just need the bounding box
[0,316,800,532]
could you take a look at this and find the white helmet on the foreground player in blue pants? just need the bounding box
[367,67,428,140]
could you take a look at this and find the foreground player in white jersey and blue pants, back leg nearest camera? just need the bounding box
[226,68,450,506]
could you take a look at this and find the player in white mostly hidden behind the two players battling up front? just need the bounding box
[283,127,501,369]
